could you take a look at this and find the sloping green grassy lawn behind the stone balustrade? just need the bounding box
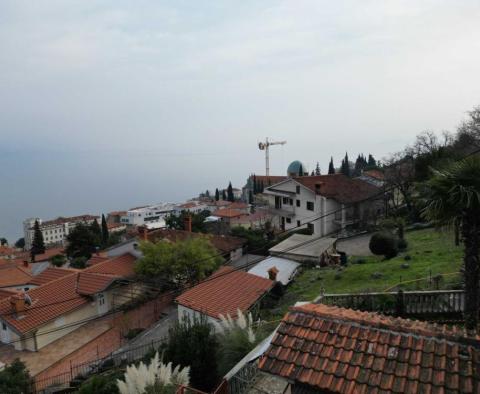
[265,229,463,317]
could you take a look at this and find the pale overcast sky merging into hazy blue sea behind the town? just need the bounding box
[0,0,480,241]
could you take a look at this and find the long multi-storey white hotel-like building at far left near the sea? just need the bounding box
[23,215,100,250]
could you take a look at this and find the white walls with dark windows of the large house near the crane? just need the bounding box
[264,179,342,236]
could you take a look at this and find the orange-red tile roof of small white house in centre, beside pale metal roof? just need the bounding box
[176,267,274,319]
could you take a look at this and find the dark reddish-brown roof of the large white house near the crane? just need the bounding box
[295,174,380,204]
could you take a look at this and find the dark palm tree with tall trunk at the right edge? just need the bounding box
[422,156,480,330]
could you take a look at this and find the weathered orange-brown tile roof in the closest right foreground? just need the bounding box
[259,304,480,393]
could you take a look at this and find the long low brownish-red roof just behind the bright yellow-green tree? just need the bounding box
[147,229,247,253]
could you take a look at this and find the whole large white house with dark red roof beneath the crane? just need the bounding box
[264,174,384,236]
